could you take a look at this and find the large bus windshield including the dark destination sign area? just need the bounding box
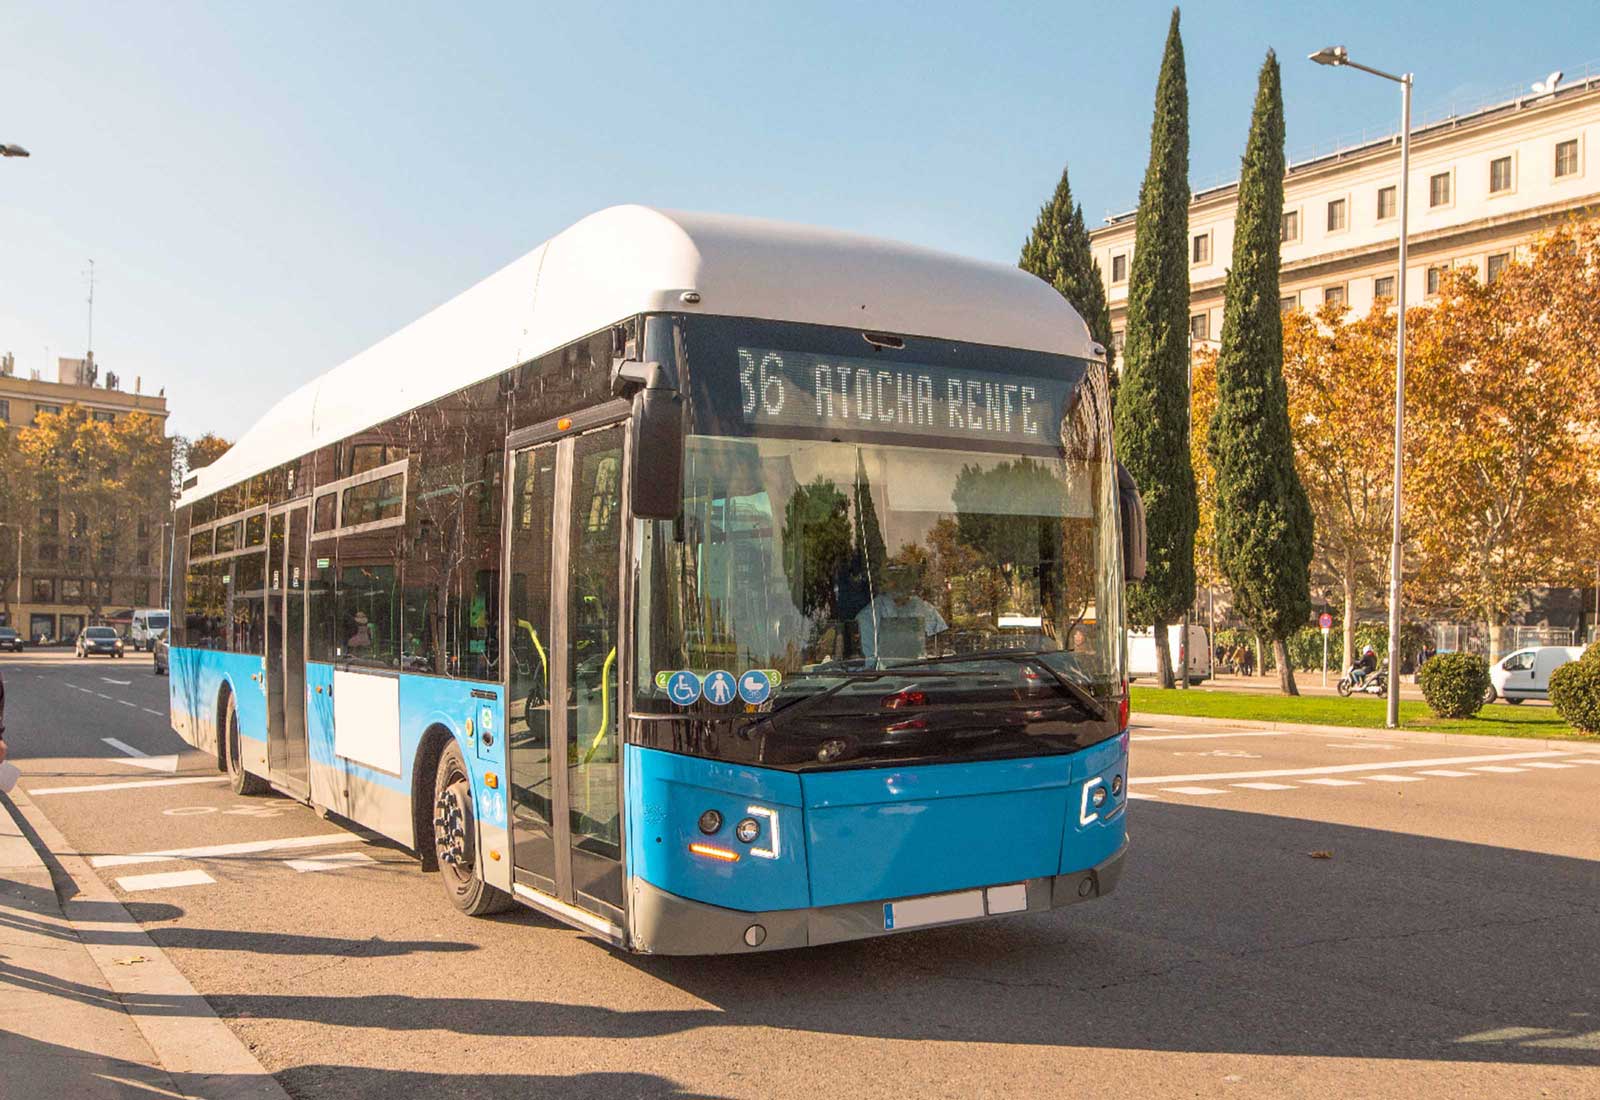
[635,318,1122,766]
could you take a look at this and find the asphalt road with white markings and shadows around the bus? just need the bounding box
[0,652,1600,1100]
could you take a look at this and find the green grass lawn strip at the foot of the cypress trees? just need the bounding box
[1133,686,1594,740]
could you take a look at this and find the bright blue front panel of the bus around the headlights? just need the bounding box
[627,735,1128,913]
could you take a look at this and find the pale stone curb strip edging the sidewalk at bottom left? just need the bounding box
[0,787,290,1100]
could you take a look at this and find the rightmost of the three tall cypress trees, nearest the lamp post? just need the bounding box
[1208,51,1312,695]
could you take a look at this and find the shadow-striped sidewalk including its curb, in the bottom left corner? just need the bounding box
[0,788,286,1100]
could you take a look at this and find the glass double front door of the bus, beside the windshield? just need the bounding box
[506,427,622,921]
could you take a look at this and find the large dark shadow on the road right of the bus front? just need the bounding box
[618,803,1600,1066]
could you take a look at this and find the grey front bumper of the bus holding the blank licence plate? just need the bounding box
[632,841,1128,955]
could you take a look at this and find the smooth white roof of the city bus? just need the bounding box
[179,206,1096,505]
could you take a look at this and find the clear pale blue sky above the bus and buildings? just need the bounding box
[0,0,1600,438]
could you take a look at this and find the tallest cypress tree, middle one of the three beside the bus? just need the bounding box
[1115,8,1203,688]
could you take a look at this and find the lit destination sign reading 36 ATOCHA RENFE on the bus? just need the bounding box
[739,347,1070,446]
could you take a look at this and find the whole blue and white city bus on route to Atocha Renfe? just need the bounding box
[170,206,1144,955]
